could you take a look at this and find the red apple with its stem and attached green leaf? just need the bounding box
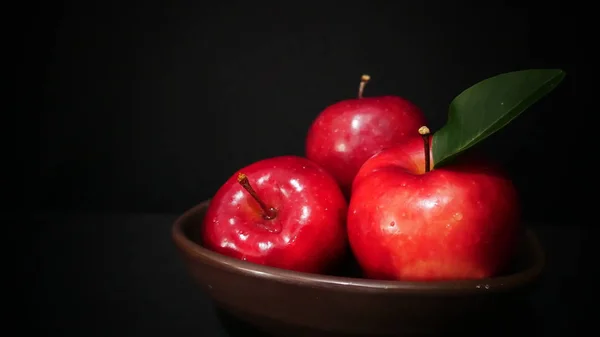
[347,69,565,281]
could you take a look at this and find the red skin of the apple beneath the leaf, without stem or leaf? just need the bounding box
[347,137,520,281]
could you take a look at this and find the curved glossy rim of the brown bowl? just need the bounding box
[171,199,546,294]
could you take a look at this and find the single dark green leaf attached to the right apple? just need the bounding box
[431,69,565,168]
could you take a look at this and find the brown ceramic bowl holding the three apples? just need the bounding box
[172,201,544,337]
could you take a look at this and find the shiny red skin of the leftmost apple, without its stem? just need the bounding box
[202,156,348,273]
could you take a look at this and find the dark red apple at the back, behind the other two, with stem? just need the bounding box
[305,75,425,194]
